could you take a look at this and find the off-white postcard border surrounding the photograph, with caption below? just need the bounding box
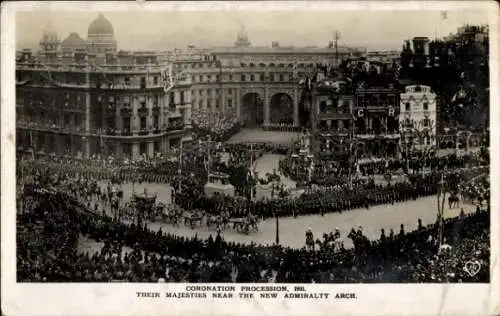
[1,1,500,316]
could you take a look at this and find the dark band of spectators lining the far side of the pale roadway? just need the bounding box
[175,168,488,219]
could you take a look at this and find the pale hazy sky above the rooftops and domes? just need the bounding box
[16,10,487,50]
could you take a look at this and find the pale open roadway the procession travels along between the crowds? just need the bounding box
[97,155,475,248]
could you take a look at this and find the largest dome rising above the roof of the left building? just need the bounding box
[87,14,117,53]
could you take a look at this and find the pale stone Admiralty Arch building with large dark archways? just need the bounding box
[186,27,366,126]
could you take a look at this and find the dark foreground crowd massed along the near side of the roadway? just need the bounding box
[17,193,490,283]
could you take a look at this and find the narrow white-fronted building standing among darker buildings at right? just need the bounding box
[399,85,437,151]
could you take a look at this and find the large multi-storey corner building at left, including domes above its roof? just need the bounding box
[16,15,191,159]
